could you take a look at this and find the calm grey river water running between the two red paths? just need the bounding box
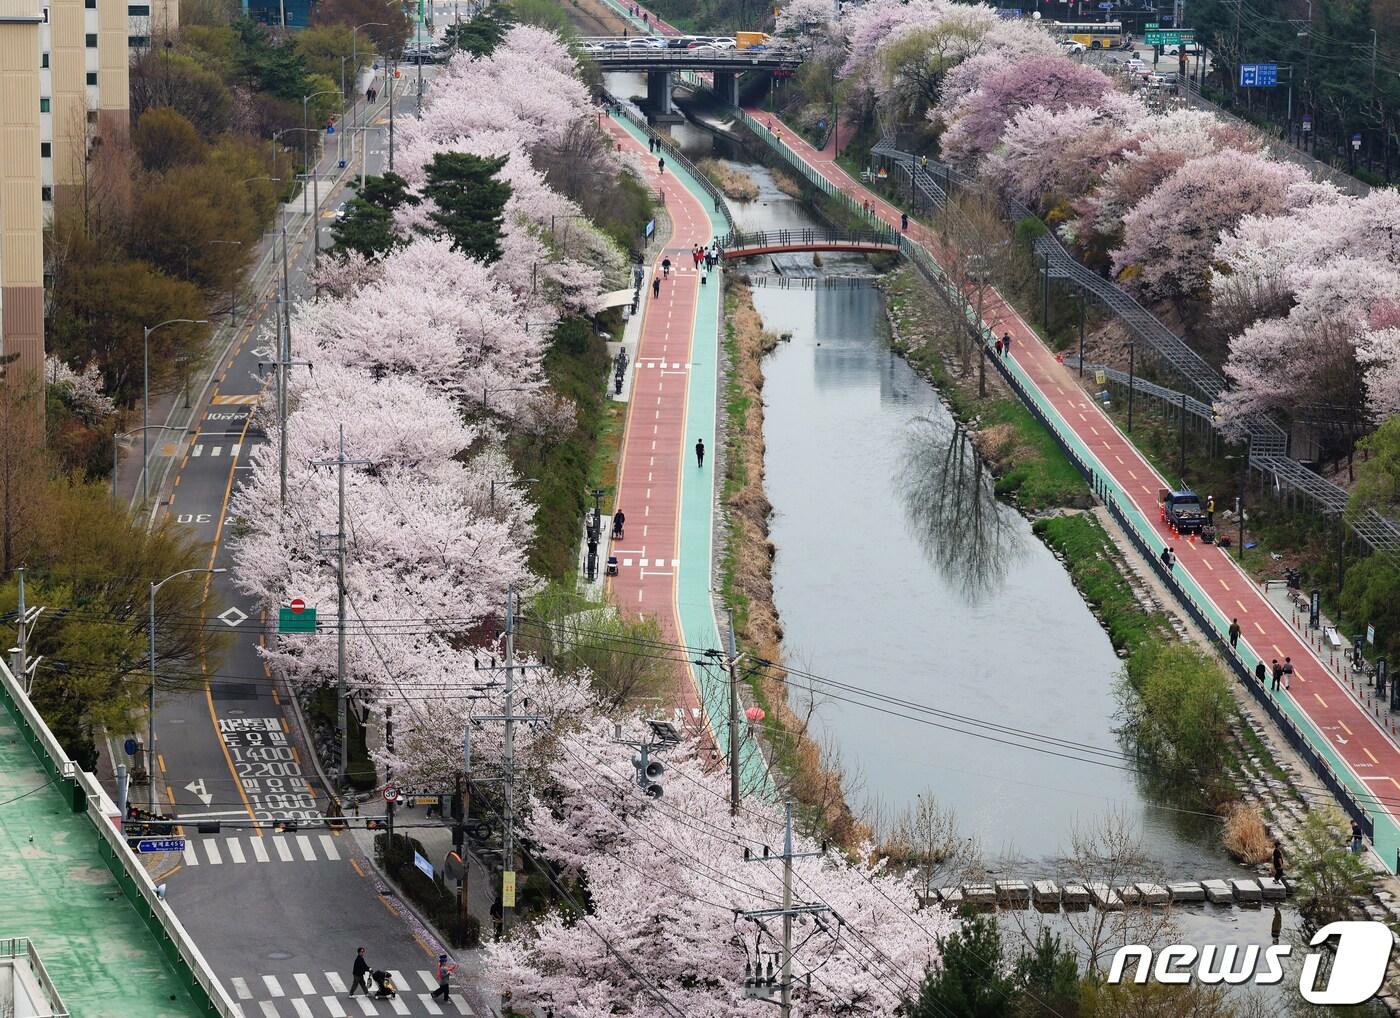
[609,76,1332,968]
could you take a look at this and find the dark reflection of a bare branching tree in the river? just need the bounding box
[899,417,1025,602]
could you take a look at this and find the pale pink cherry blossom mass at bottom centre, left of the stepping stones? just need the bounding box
[486,711,956,1018]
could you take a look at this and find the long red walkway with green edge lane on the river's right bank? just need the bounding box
[749,109,1400,864]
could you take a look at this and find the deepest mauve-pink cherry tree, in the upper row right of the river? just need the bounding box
[935,56,1113,168]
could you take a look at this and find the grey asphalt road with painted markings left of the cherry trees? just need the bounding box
[137,69,487,1018]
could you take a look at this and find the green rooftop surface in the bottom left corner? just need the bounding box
[0,706,202,1018]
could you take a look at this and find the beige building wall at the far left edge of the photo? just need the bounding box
[0,0,43,389]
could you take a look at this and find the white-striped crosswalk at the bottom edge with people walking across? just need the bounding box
[227,969,476,1018]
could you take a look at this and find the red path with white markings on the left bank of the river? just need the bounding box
[603,119,713,709]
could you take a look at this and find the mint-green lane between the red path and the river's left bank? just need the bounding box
[613,109,773,795]
